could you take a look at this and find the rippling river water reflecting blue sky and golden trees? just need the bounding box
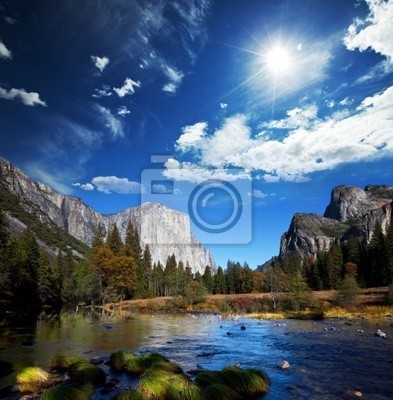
[0,314,393,400]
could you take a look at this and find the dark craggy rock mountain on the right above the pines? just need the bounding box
[280,185,393,258]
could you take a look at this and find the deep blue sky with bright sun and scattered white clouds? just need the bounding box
[0,0,393,268]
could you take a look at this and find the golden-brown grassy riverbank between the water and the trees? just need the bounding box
[103,287,393,319]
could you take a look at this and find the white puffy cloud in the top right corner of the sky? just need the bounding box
[344,0,393,62]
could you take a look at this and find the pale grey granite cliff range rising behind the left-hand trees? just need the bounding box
[0,158,216,273]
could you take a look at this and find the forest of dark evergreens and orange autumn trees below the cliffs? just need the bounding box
[0,203,393,311]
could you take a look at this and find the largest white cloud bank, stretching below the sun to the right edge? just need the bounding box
[167,86,393,182]
